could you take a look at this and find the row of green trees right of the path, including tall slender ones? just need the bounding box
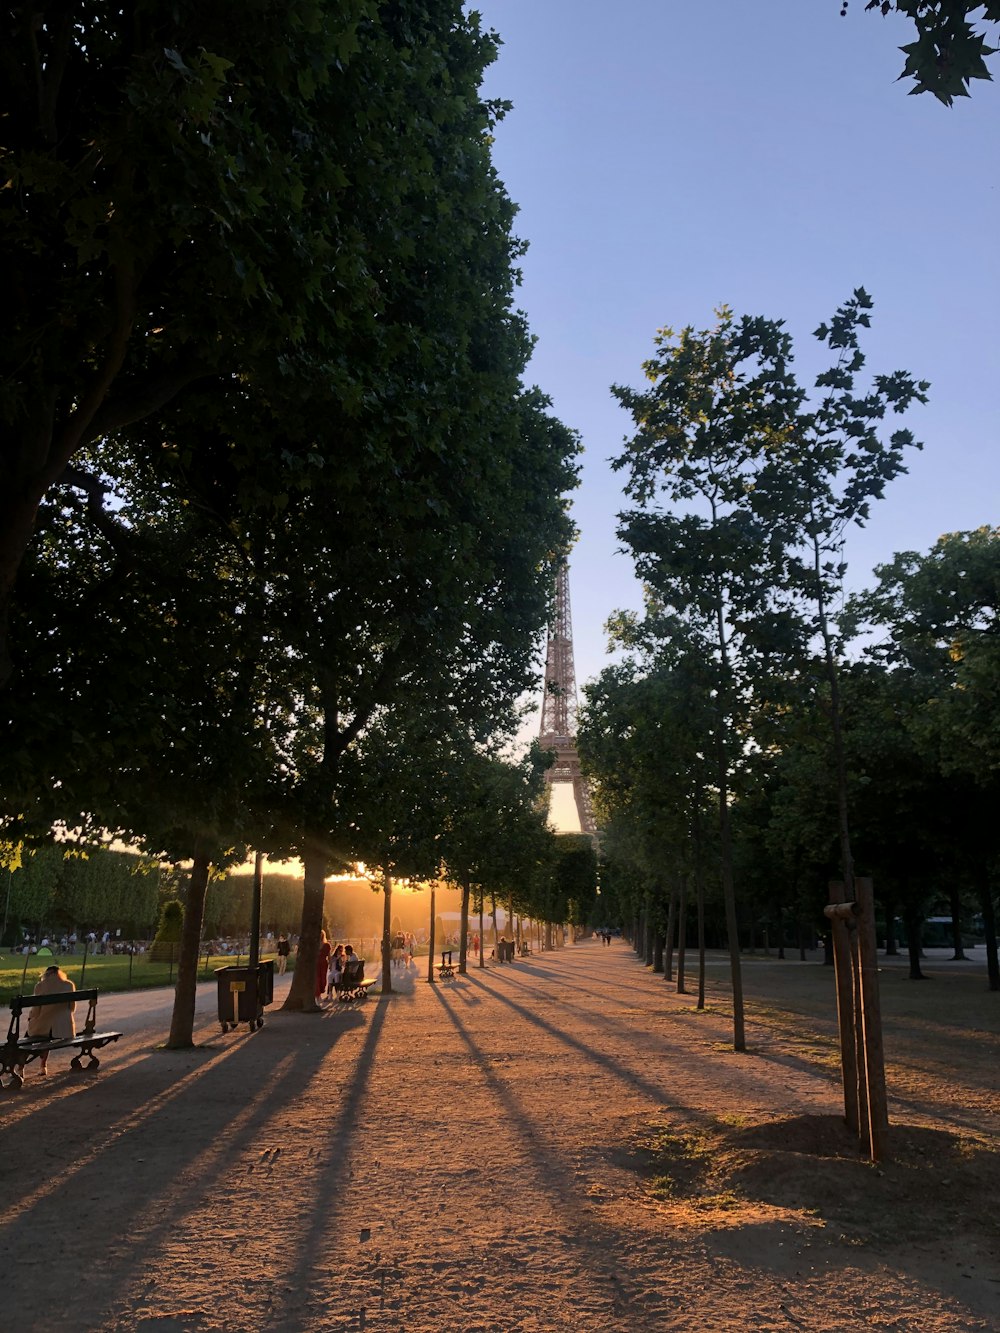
[580,289,1000,1049]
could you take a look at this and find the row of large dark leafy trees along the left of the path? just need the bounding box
[0,0,579,1045]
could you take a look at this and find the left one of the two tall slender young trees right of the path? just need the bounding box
[612,307,816,1050]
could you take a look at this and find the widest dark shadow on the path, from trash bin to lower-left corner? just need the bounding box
[0,1013,380,1326]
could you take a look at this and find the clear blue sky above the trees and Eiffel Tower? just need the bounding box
[469,0,1000,709]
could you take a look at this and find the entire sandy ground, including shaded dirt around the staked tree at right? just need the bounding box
[0,942,1000,1333]
